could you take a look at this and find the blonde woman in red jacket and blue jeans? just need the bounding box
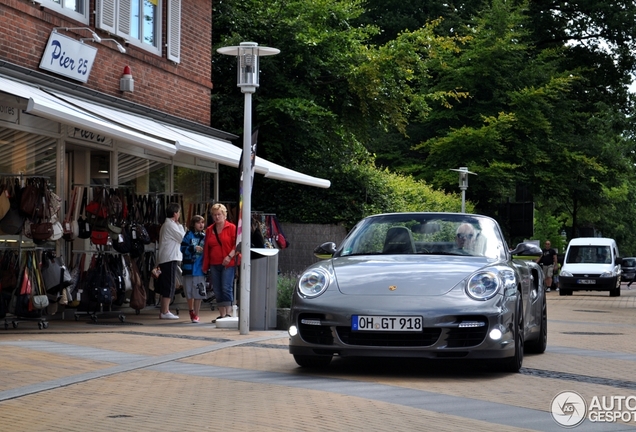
[202,204,237,323]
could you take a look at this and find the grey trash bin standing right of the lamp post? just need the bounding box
[250,248,278,330]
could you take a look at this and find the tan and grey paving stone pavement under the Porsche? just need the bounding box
[0,287,636,432]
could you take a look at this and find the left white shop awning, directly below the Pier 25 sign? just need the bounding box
[0,77,177,155]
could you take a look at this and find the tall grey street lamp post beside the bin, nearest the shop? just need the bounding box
[217,42,280,335]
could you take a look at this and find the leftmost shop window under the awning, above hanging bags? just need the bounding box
[0,128,57,181]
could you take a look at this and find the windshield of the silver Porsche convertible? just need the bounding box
[336,213,505,258]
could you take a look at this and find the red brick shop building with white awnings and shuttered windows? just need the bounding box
[0,0,328,248]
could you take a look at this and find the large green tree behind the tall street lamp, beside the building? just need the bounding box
[213,0,458,223]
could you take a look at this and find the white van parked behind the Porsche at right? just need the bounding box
[559,237,623,297]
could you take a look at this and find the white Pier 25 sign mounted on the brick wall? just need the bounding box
[40,31,97,83]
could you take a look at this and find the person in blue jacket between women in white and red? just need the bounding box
[181,215,206,323]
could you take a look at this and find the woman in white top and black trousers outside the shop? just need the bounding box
[155,203,185,320]
